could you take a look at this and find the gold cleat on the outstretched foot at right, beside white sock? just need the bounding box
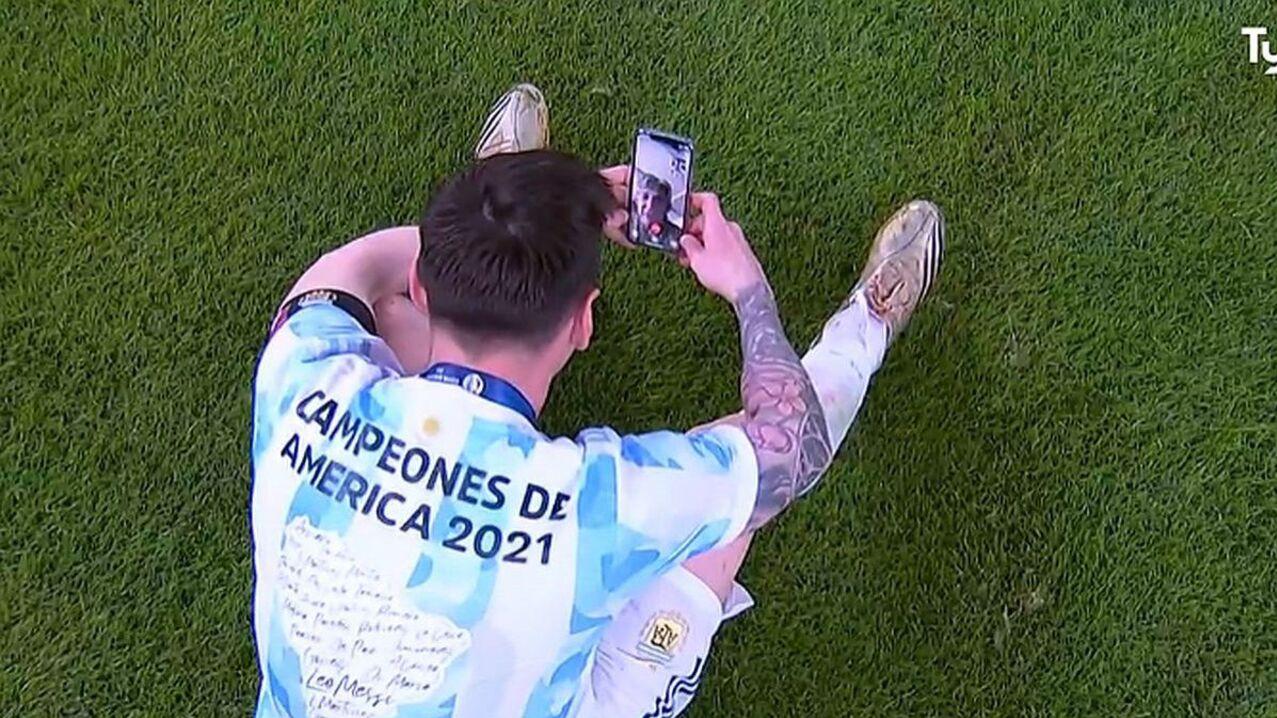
[844,199,945,341]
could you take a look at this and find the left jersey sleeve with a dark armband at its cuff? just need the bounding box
[253,290,401,451]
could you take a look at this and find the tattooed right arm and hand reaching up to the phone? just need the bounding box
[683,194,833,530]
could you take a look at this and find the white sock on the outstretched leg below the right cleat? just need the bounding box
[802,291,888,451]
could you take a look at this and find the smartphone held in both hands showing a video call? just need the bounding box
[626,128,693,253]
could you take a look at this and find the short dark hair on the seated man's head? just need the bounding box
[416,149,616,344]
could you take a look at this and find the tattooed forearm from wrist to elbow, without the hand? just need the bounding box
[736,281,833,529]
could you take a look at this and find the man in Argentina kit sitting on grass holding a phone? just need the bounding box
[252,86,942,718]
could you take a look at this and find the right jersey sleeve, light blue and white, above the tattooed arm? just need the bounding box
[577,425,759,593]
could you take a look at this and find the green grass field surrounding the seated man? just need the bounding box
[0,0,1277,717]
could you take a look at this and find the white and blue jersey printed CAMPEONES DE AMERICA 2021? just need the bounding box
[252,291,757,718]
